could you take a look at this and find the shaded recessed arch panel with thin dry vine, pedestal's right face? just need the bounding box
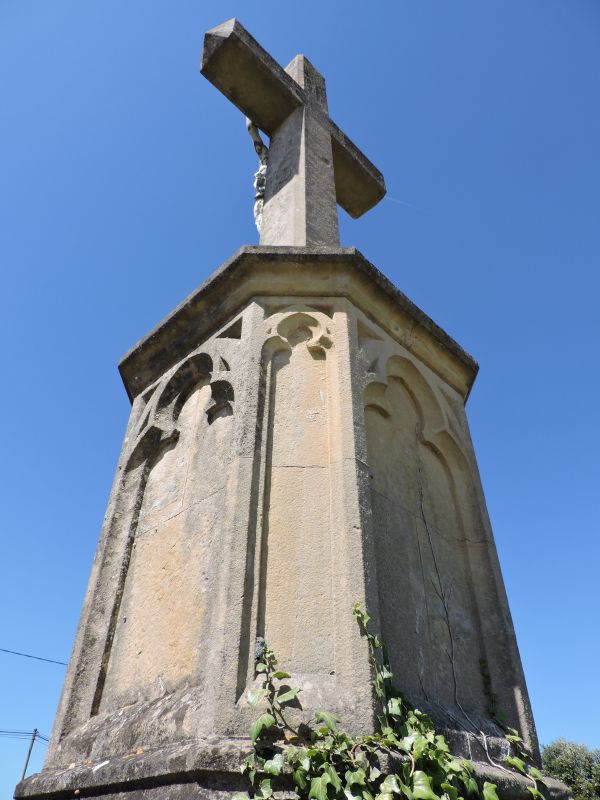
[363,355,489,729]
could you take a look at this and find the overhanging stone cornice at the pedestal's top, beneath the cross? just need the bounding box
[119,246,479,400]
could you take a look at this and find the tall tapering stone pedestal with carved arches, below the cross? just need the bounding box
[17,247,560,800]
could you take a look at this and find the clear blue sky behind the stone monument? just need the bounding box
[0,0,600,796]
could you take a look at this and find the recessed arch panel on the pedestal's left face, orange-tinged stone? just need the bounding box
[95,352,235,713]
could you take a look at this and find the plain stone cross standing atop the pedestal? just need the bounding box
[200,19,385,247]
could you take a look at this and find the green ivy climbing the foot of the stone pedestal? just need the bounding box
[233,604,543,800]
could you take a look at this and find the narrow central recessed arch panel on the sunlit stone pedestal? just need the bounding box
[250,306,335,676]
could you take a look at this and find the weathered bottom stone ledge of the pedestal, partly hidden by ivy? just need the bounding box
[15,739,570,800]
